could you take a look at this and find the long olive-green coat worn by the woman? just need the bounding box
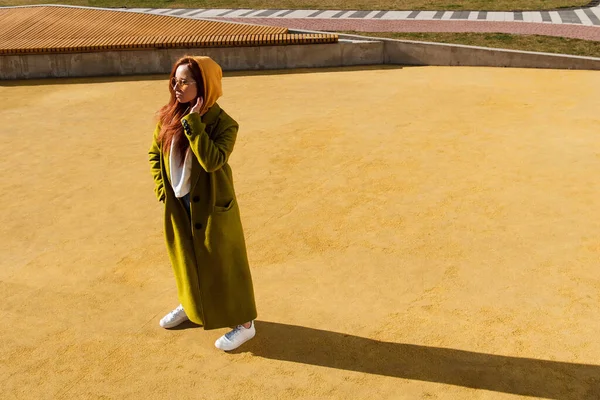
[149,104,256,329]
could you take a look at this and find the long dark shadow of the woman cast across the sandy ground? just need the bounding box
[234,321,600,399]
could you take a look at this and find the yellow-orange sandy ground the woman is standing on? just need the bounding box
[0,67,600,399]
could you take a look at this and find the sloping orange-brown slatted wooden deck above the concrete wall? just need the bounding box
[0,6,338,54]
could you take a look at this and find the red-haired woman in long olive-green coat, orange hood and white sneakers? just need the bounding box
[149,57,256,351]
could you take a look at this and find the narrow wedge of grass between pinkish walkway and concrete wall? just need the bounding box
[340,31,600,57]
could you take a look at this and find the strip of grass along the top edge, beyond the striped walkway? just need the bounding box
[0,0,590,11]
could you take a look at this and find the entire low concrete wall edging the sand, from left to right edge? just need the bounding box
[0,35,600,79]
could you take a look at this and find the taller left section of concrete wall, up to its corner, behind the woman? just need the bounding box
[0,41,384,79]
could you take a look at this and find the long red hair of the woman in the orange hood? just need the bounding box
[157,56,204,163]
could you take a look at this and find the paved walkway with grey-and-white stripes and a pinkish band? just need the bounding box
[126,6,600,41]
